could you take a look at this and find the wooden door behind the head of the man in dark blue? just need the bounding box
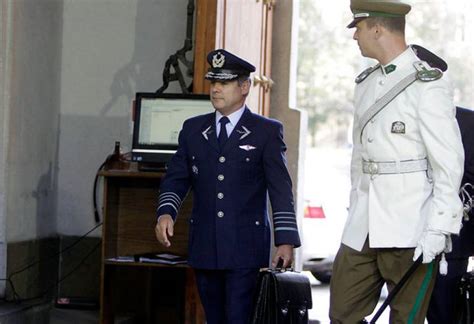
[193,0,275,116]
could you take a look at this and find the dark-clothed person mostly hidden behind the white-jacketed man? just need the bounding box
[427,107,474,324]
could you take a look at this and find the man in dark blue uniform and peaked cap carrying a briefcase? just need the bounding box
[155,49,300,324]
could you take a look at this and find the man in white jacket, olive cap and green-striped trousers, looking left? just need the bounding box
[330,0,464,324]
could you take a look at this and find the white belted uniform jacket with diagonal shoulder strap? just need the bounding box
[342,48,464,251]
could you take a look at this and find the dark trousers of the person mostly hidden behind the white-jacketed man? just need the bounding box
[426,258,469,324]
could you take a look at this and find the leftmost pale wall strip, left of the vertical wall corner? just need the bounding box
[0,0,62,243]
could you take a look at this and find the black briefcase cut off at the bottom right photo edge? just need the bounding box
[453,272,474,324]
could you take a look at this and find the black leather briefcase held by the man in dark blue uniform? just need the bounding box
[251,268,313,324]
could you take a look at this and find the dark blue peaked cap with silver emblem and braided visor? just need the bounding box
[205,49,255,81]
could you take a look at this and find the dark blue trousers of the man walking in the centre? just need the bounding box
[194,269,259,324]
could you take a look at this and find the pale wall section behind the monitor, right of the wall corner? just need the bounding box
[57,0,188,235]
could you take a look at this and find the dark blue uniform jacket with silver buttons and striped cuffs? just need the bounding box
[157,108,300,269]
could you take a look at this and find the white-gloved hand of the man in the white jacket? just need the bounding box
[413,230,451,263]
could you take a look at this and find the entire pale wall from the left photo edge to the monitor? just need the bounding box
[0,0,193,240]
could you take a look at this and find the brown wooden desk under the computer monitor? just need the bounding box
[99,164,204,324]
